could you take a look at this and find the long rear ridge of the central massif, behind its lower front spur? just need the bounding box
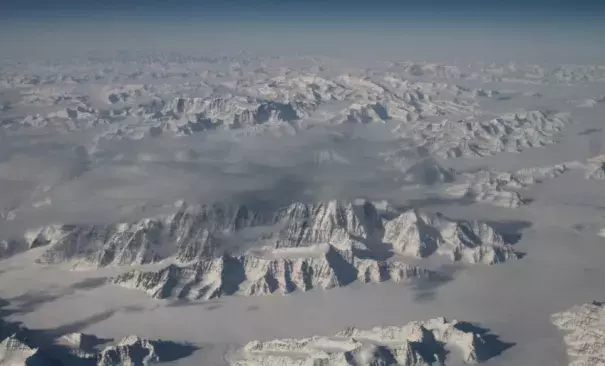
[26,201,515,268]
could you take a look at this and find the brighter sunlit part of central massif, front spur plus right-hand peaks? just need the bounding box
[112,202,522,299]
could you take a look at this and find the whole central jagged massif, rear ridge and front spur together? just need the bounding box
[9,200,521,299]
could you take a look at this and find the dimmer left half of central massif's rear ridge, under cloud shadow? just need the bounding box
[26,205,257,267]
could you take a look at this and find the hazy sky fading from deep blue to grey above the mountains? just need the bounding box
[0,0,605,63]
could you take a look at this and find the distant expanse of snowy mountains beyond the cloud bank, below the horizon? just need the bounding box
[3,57,576,162]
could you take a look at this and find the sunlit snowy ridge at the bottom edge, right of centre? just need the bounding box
[228,318,506,366]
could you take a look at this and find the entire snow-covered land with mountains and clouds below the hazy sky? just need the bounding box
[0,54,605,366]
